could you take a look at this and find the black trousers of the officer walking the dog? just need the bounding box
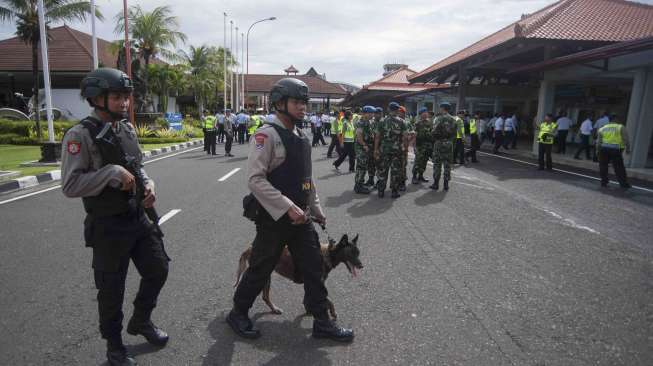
[234,213,328,318]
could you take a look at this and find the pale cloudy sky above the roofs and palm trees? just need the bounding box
[0,0,653,86]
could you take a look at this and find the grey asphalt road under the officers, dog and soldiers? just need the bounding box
[0,138,653,365]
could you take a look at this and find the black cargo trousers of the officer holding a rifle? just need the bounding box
[85,209,170,340]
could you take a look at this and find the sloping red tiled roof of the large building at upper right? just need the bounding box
[409,0,653,80]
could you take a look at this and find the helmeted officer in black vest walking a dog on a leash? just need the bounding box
[227,78,354,342]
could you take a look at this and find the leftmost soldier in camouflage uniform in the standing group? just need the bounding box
[354,105,376,194]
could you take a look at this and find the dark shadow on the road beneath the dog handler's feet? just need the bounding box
[202,312,347,366]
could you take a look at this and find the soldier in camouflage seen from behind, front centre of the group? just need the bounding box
[374,102,407,198]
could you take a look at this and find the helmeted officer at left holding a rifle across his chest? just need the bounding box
[61,68,169,365]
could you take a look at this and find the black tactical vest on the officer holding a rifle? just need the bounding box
[80,117,133,217]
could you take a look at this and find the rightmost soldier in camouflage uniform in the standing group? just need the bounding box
[430,103,456,191]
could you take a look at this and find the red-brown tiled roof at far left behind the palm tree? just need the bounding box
[0,25,117,72]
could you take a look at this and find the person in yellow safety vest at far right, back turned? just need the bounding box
[596,115,631,189]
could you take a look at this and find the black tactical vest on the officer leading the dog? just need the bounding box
[267,124,313,210]
